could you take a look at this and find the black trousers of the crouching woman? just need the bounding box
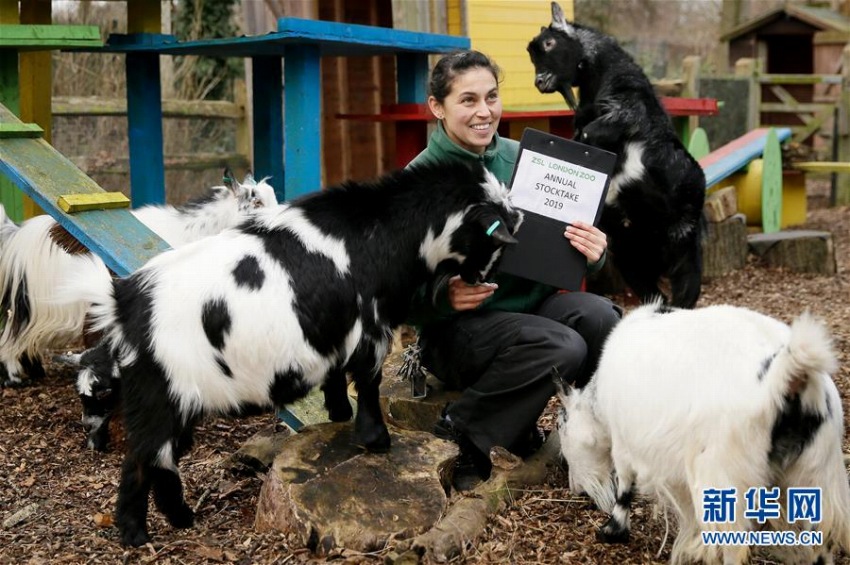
[421,292,622,453]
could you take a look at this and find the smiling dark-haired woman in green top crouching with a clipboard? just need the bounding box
[408,50,622,490]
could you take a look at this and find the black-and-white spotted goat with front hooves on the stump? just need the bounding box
[63,163,522,546]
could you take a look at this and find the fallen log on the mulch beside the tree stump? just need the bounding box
[387,433,561,565]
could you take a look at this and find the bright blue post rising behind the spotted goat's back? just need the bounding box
[283,45,322,200]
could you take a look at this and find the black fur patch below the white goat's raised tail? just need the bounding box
[768,395,829,469]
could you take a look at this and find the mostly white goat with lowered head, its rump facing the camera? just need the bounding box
[558,304,850,564]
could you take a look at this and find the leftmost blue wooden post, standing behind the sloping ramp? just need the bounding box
[126,53,165,208]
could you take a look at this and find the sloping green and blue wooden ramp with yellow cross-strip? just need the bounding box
[0,100,327,431]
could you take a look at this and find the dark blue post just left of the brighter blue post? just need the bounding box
[251,57,284,202]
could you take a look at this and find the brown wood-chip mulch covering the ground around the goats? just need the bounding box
[0,182,850,565]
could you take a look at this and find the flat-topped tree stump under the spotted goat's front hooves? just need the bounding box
[255,422,457,555]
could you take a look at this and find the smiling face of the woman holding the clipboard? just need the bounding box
[428,67,502,154]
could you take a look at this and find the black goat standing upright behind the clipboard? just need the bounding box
[528,2,705,308]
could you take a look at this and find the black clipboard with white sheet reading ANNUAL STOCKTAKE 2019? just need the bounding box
[499,128,617,290]
